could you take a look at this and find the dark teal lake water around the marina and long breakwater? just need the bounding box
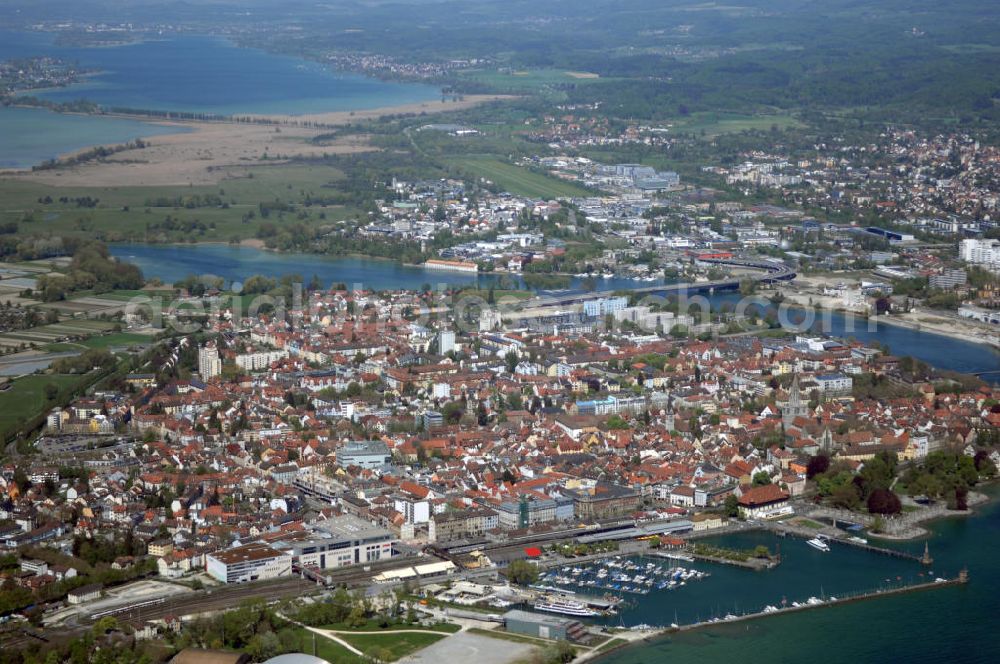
[600,486,1000,664]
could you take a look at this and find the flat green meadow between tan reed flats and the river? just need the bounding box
[0,165,352,242]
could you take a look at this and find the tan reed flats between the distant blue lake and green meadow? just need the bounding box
[0,95,508,187]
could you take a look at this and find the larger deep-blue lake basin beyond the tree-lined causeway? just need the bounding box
[0,31,441,115]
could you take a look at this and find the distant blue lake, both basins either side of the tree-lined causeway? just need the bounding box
[0,30,440,168]
